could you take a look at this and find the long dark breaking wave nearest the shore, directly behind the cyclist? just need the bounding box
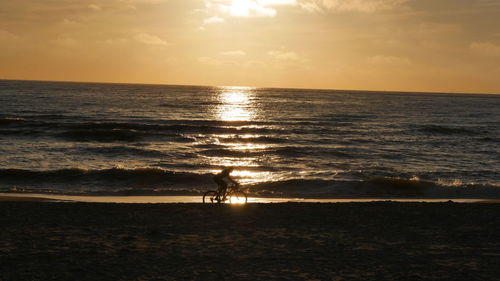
[0,168,500,199]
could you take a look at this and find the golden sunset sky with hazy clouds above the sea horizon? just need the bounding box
[0,0,500,93]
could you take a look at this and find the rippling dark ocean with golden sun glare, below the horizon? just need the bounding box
[0,80,500,199]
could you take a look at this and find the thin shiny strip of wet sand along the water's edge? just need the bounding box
[0,193,500,204]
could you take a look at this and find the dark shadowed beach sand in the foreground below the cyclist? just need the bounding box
[0,202,500,281]
